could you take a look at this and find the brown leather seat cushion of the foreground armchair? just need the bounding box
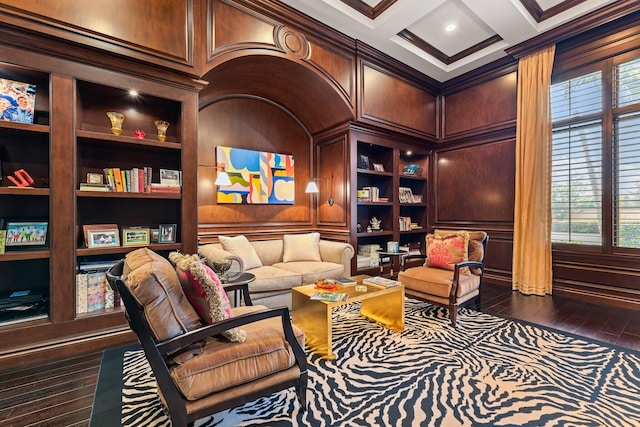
[171,305,304,400]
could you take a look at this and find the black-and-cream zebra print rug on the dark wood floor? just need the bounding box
[102,298,640,427]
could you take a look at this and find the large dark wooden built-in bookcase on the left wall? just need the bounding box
[0,49,197,366]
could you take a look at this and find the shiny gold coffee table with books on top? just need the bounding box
[291,276,404,360]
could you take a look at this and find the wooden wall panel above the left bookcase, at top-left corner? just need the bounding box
[0,0,194,73]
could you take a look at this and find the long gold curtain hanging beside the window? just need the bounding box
[512,45,555,295]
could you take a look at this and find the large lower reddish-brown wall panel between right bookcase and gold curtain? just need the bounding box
[432,138,515,226]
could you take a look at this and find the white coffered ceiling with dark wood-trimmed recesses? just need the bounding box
[282,0,615,82]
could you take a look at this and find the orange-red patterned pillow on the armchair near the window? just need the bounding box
[427,232,469,274]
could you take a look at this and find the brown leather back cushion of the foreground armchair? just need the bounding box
[122,248,202,341]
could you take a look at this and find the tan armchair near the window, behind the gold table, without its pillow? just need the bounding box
[398,230,489,327]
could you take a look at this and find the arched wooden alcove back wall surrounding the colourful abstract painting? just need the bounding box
[197,96,312,230]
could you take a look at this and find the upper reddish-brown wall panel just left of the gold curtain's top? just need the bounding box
[441,72,517,142]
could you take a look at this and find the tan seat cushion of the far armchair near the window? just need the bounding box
[398,266,480,298]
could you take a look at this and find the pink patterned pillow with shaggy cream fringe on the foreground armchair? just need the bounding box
[169,252,247,342]
